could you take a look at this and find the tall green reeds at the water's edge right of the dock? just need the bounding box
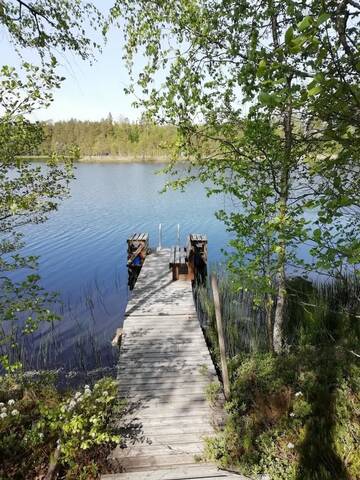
[194,265,360,358]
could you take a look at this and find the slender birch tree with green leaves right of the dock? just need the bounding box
[113,0,359,352]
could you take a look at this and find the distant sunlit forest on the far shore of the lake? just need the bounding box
[36,115,176,158]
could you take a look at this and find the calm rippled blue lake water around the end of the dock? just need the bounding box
[20,164,233,368]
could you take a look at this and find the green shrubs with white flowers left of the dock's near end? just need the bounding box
[0,375,122,479]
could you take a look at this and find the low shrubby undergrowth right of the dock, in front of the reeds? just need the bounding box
[206,348,360,480]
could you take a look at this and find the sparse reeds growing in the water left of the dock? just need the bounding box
[0,275,123,373]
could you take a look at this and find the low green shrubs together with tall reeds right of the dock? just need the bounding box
[197,276,360,480]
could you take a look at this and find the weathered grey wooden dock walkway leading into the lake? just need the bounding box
[102,249,245,480]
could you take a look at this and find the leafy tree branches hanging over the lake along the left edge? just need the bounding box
[0,0,103,367]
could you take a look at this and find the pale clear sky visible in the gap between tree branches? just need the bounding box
[0,0,140,120]
